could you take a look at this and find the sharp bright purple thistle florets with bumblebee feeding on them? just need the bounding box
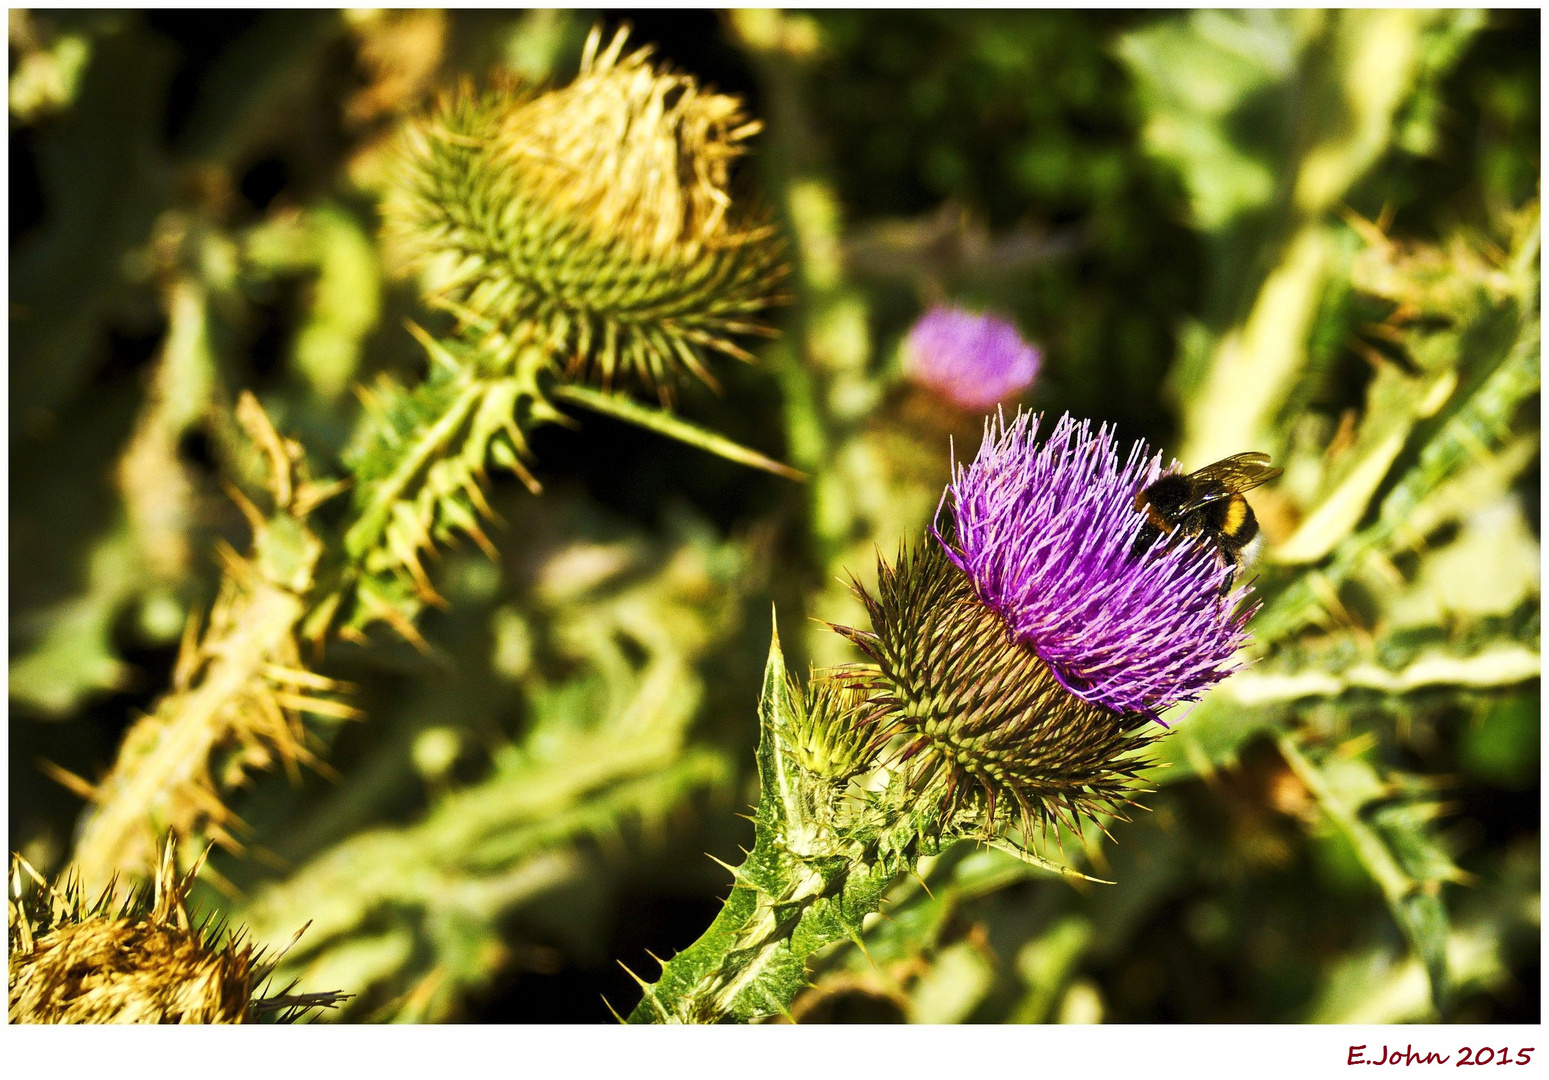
[948,415,1253,717]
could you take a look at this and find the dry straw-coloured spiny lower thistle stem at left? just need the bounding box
[58,394,358,889]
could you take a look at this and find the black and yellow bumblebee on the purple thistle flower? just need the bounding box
[1131,454,1283,584]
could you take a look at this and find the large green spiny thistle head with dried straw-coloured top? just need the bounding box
[384,29,785,394]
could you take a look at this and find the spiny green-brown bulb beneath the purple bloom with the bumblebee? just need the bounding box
[835,539,1152,838]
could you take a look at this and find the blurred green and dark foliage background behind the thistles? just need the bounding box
[8,11,1540,1023]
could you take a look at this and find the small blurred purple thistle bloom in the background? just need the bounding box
[903,307,1041,409]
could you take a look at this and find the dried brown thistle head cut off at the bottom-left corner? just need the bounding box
[8,838,341,1024]
